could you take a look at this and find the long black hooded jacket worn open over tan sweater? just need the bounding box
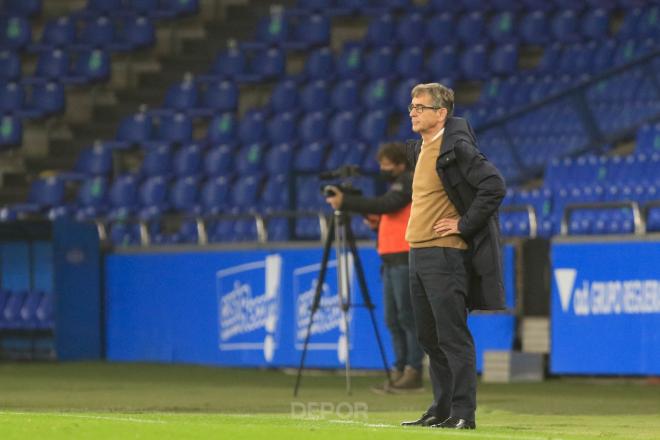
[406,117,506,310]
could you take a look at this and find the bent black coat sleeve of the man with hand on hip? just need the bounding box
[455,140,506,237]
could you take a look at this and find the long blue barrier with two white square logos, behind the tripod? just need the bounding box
[106,246,514,368]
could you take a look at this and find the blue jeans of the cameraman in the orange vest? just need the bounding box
[383,263,424,371]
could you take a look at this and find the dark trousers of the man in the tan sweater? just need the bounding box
[410,247,477,420]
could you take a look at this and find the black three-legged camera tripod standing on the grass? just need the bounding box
[293,210,391,397]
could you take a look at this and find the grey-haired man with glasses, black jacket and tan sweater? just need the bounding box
[402,83,505,429]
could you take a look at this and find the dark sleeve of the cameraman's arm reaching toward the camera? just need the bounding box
[341,172,412,214]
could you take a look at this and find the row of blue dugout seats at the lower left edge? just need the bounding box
[0,289,55,331]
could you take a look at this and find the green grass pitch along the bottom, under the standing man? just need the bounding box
[0,363,660,440]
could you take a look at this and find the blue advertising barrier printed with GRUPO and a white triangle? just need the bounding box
[551,241,660,375]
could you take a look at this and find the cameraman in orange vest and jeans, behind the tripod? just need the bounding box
[326,143,424,392]
